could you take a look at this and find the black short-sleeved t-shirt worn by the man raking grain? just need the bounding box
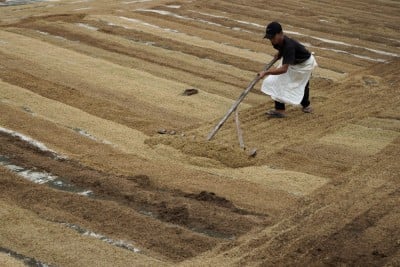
[274,35,311,65]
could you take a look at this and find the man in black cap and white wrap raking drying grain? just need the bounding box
[259,22,317,118]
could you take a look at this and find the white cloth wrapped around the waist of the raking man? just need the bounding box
[261,55,317,105]
